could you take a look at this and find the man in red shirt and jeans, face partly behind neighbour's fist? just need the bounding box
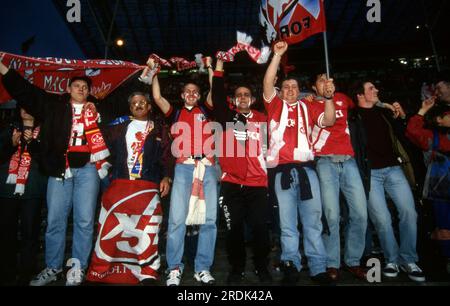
[312,74,367,280]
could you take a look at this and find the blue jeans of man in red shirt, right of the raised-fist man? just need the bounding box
[316,157,367,269]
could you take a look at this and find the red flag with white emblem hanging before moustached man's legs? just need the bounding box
[86,179,162,284]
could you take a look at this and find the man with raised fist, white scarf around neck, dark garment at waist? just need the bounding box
[264,42,336,284]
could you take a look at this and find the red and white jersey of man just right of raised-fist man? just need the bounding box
[312,93,355,156]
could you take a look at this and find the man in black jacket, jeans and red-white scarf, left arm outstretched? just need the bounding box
[0,62,109,286]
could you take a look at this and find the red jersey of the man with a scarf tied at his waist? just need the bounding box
[166,106,214,163]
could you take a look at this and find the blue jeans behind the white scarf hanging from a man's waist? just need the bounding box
[166,164,218,272]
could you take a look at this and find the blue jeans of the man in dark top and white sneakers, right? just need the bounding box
[368,166,418,264]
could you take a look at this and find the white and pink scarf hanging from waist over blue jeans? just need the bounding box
[183,157,212,225]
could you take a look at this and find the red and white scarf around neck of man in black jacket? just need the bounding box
[64,104,111,179]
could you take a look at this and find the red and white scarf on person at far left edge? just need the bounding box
[6,127,40,195]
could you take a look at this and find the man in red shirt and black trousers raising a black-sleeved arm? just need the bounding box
[212,59,272,284]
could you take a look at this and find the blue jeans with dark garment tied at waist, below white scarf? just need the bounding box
[275,168,327,276]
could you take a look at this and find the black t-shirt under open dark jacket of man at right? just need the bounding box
[359,107,398,169]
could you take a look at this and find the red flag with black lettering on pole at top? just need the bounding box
[260,0,326,44]
